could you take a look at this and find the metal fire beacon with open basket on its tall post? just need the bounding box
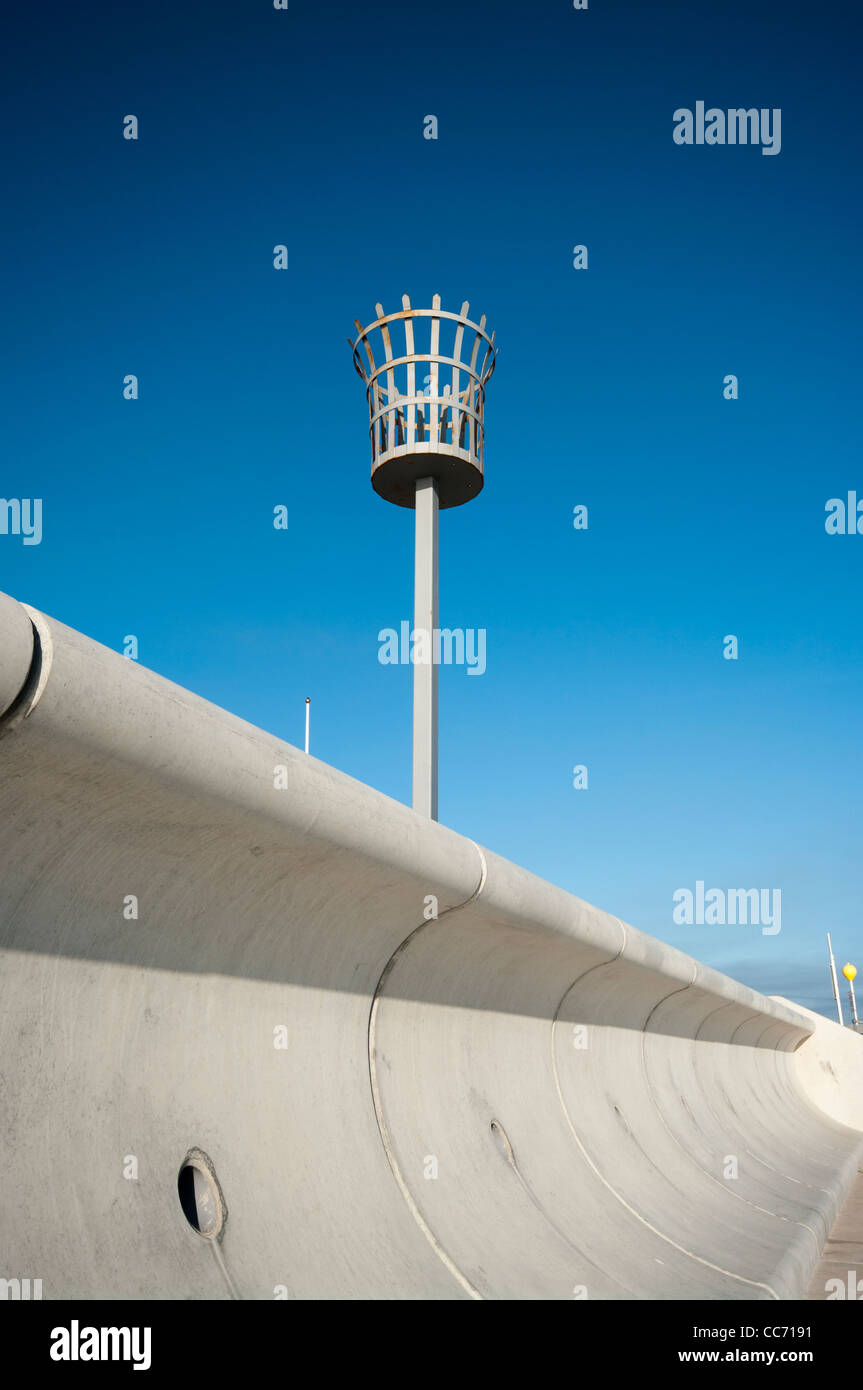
[347,295,498,820]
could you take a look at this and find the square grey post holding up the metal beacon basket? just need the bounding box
[413,478,438,820]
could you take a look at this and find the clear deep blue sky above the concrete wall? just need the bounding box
[0,0,863,1011]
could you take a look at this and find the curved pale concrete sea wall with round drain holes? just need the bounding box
[0,600,863,1298]
